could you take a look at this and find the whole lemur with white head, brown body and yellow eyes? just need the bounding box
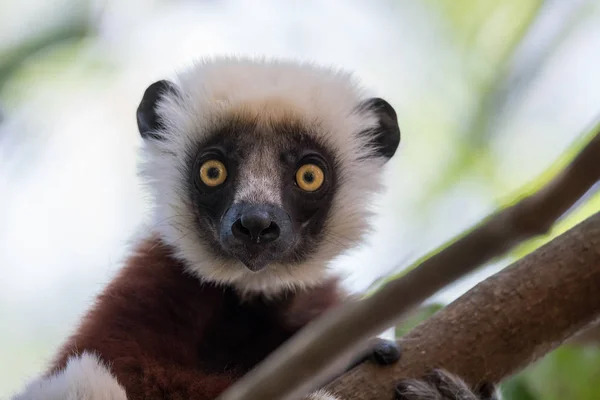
[14,57,500,400]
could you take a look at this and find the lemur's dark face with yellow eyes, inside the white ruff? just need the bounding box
[188,120,337,272]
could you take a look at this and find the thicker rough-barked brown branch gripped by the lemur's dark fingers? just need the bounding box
[328,213,600,400]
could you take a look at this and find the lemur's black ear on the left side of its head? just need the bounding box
[137,80,178,140]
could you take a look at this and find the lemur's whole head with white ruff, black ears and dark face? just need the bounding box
[137,58,400,293]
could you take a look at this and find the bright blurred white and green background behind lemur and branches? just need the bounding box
[0,0,600,400]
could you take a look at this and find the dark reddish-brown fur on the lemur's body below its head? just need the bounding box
[48,239,340,400]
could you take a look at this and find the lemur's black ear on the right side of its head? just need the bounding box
[360,97,400,159]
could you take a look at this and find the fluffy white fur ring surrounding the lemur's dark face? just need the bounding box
[141,58,385,295]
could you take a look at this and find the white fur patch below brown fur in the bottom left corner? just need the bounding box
[11,353,127,400]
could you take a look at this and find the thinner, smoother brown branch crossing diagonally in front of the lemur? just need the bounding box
[219,133,600,400]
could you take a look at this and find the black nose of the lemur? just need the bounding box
[231,208,280,243]
